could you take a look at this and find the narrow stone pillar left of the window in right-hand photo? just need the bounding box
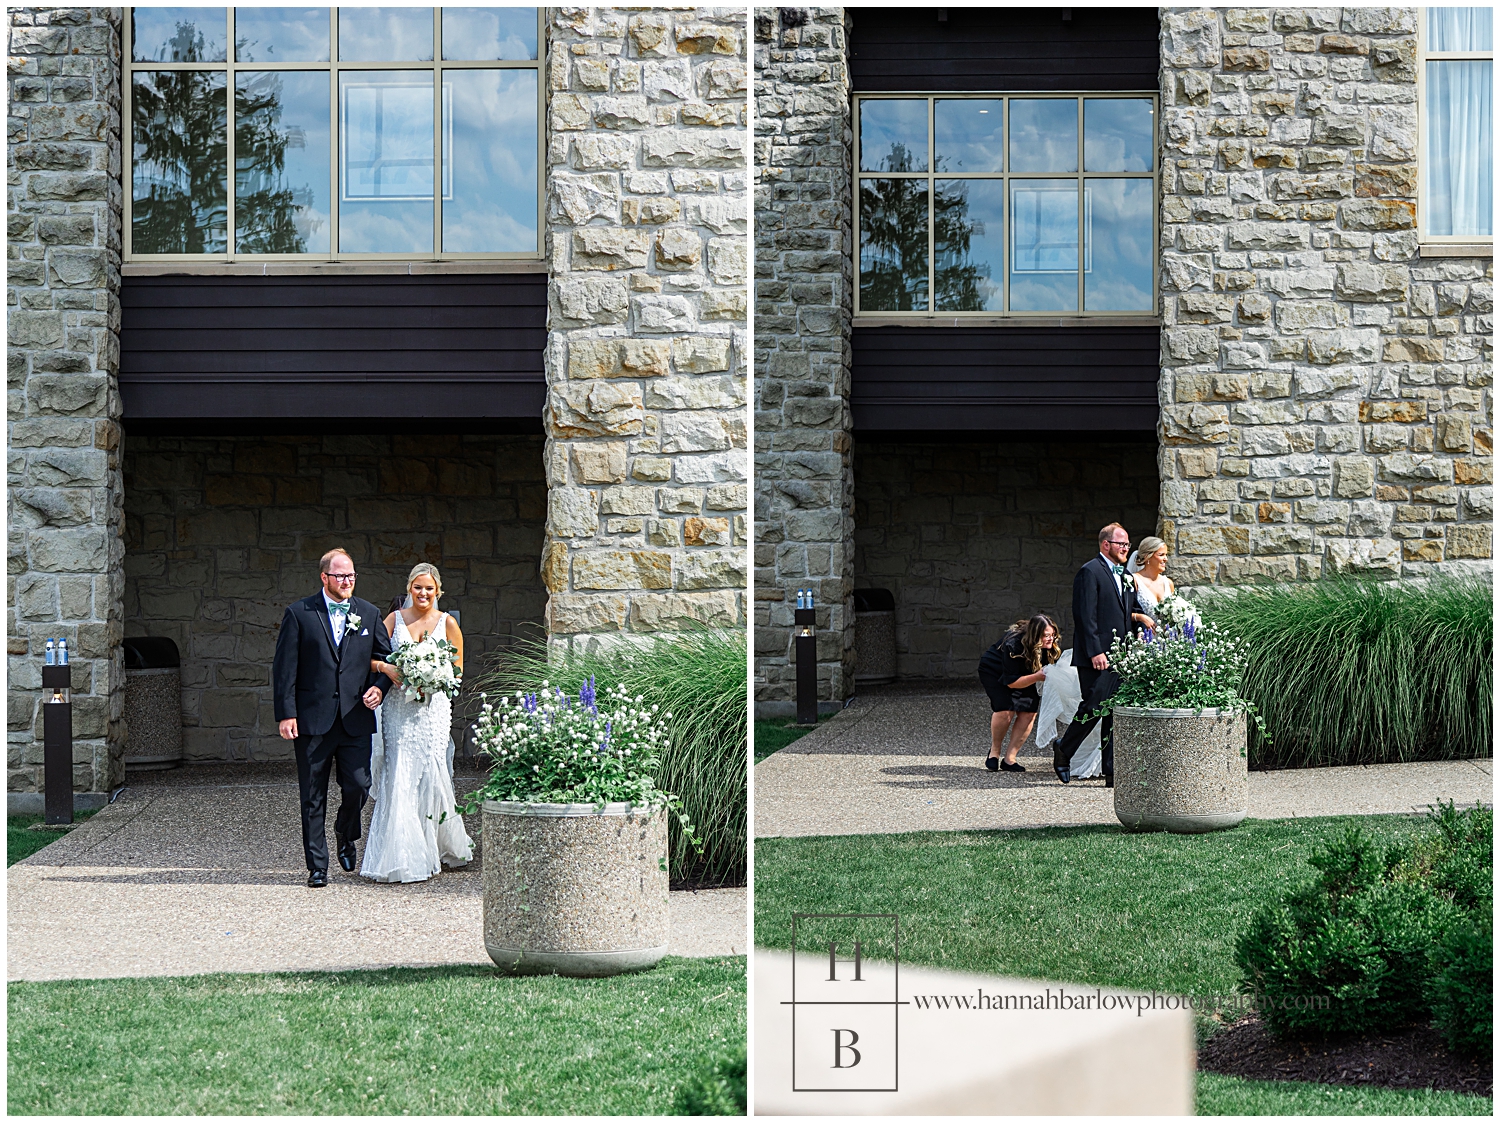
[755,7,855,717]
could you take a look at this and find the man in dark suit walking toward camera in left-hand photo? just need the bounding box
[272,550,392,889]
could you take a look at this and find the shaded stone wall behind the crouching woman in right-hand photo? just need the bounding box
[854,433,1158,679]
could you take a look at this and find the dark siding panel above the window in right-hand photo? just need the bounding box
[849,7,1160,93]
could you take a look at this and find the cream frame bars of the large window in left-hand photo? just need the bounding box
[120,3,546,264]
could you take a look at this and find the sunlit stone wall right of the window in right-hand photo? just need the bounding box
[1161,7,1493,585]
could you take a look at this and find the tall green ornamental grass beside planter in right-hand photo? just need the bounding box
[1200,579,1493,768]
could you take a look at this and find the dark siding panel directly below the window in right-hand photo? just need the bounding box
[854,327,1161,432]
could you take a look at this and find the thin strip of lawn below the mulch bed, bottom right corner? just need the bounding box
[1199,1072,1494,1116]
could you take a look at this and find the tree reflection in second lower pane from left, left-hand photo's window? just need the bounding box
[234,73,321,253]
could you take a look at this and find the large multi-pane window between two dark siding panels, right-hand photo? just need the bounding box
[855,94,1157,316]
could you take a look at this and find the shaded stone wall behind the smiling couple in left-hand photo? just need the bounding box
[125,433,546,760]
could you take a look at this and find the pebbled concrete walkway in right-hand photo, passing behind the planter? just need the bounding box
[755,682,1494,838]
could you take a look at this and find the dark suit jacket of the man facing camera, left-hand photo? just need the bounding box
[272,591,392,738]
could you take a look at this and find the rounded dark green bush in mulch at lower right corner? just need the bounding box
[1235,804,1494,1051]
